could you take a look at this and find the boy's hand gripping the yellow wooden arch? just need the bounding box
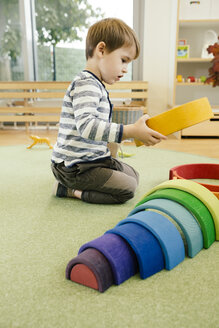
[123,114,167,146]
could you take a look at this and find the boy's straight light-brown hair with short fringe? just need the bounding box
[86,18,140,59]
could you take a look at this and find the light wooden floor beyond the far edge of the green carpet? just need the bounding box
[0,128,219,159]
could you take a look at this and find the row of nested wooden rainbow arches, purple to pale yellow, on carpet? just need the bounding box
[66,179,219,292]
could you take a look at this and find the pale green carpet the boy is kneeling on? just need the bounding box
[0,145,219,328]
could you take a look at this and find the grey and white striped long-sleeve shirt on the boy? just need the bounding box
[52,71,123,167]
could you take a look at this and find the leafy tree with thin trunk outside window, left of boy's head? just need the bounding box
[35,0,102,80]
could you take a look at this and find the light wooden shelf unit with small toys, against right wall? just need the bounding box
[173,0,219,137]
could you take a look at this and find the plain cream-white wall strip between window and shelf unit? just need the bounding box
[142,0,177,116]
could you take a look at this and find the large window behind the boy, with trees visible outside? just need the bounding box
[0,0,133,81]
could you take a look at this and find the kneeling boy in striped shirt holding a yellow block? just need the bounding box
[52,18,166,204]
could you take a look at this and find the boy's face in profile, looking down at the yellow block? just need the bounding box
[99,45,135,84]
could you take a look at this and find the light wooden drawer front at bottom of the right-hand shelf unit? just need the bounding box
[181,117,219,137]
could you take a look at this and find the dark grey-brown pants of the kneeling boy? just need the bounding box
[52,158,139,204]
